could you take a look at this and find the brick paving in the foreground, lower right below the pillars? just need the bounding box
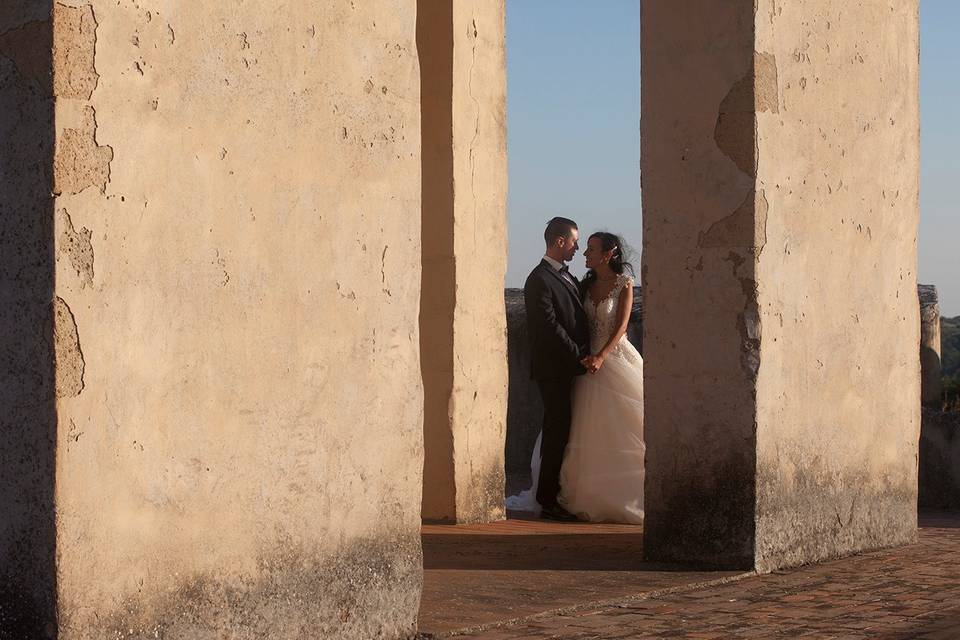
[425,514,960,640]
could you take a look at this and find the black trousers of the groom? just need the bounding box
[537,378,573,507]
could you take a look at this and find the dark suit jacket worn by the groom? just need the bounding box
[523,260,590,379]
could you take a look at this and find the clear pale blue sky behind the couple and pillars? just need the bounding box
[507,0,960,316]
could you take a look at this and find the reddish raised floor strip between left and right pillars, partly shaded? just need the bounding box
[419,519,735,637]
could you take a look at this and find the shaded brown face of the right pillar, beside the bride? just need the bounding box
[640,0,766,566]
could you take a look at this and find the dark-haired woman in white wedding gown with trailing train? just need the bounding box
[507,231,645,524]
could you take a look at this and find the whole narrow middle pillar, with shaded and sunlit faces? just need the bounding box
[418,0,507,522]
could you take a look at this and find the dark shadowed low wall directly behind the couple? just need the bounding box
[504,287,643,488]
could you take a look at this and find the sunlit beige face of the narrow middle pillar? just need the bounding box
[450,0,508,522]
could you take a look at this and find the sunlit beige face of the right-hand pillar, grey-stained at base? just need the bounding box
[756,0,920,569]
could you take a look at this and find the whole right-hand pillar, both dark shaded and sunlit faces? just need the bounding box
[641,0,920,570]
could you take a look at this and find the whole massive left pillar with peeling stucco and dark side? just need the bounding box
[0,0,423,640]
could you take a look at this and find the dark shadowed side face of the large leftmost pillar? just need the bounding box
[0,0,57,640]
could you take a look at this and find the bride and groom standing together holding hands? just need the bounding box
[507,218,645,524]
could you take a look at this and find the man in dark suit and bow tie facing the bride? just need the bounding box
[523,218,590,521]
